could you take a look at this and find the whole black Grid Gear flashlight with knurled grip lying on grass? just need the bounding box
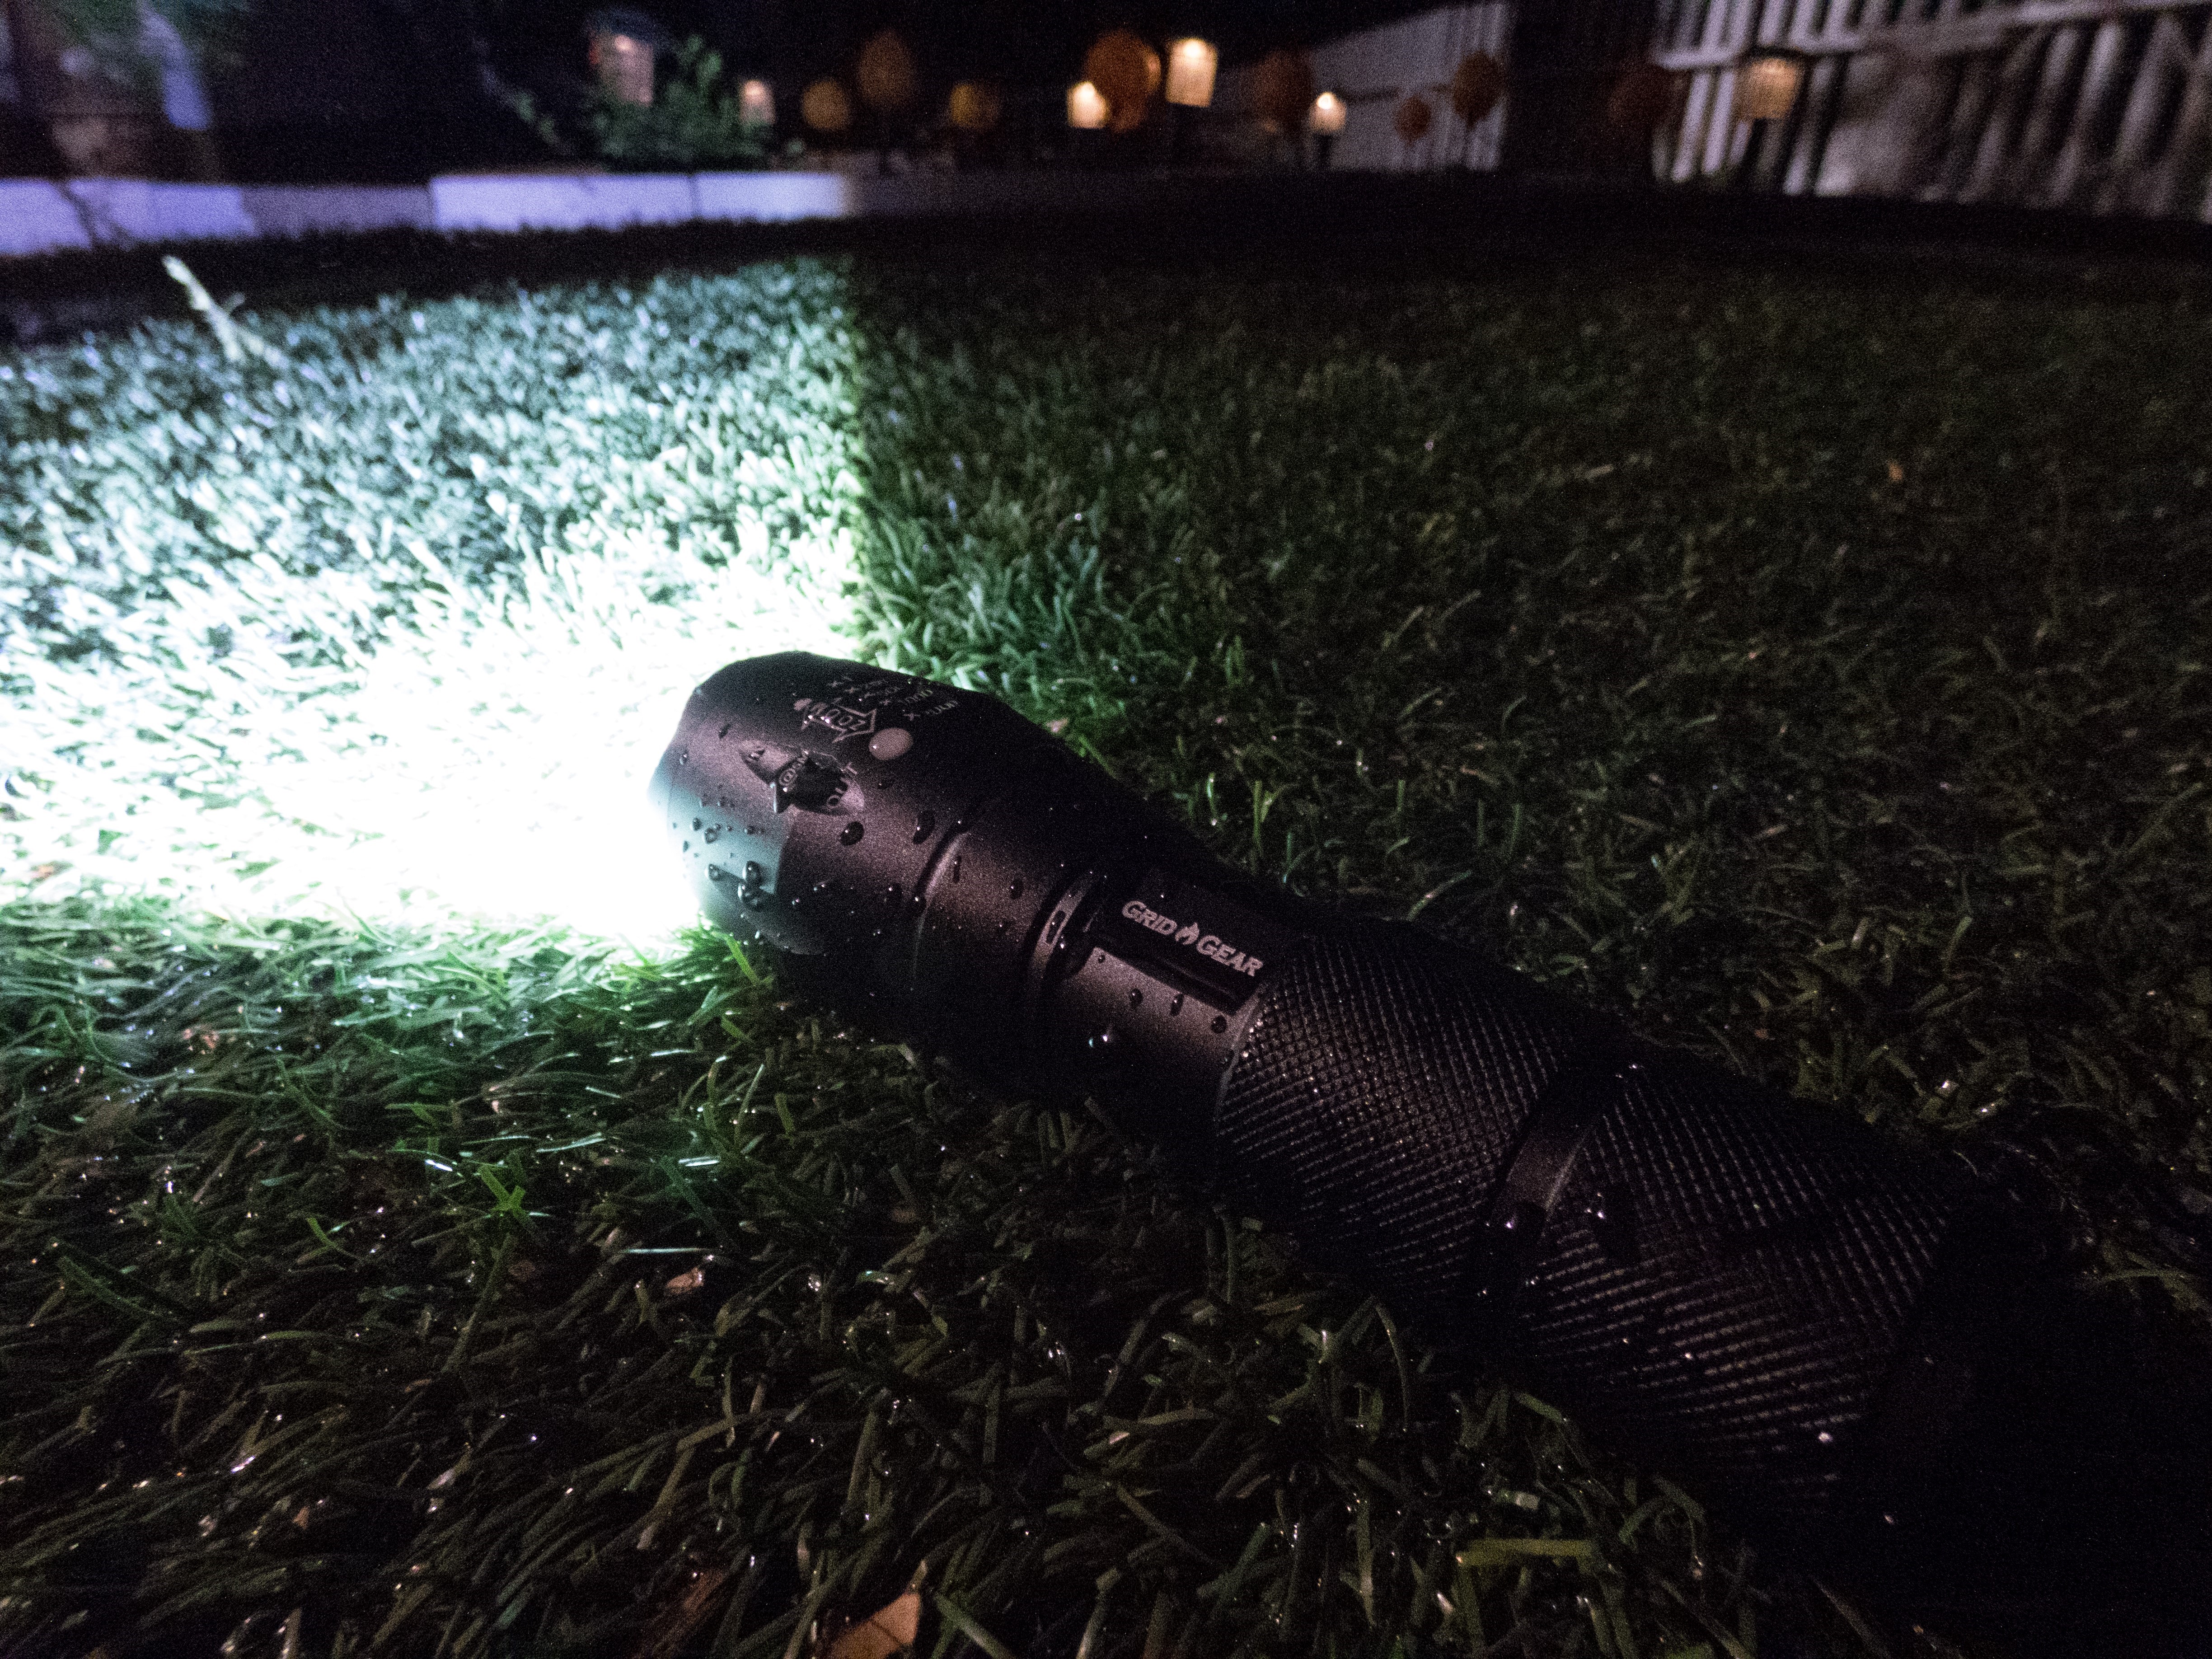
[652,652,2212,1652]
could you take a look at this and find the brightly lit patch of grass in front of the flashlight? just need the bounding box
[0,267,854,938]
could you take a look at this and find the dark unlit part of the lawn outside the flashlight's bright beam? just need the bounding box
[0,236,2212,1659]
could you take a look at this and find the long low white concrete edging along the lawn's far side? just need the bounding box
[0,173,1163,257]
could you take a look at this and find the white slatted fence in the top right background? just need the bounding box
[1652,0,2212,219]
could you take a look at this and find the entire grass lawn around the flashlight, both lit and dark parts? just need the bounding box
[0,236,2212,1659]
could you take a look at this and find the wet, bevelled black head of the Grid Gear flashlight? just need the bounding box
[652,652,1203,1066]
